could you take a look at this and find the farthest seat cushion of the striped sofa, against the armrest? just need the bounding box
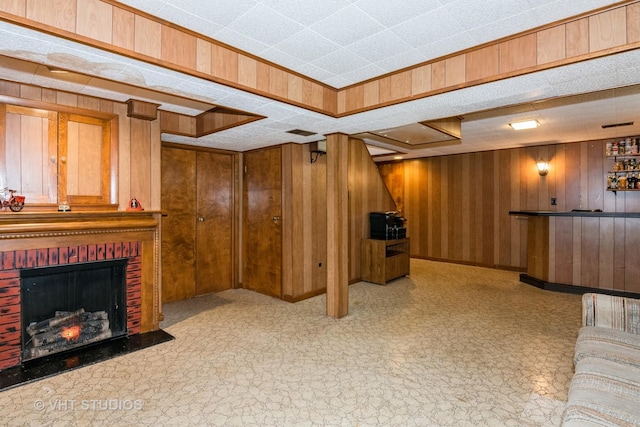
[574,326,640,369]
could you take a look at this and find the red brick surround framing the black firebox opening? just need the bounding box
[0,241,142,370]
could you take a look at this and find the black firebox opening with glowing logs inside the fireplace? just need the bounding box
[20,259,128,362]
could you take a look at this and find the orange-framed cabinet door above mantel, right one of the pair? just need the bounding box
[58,113,111,206]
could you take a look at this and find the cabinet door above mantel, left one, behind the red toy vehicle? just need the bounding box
[0,104,58,204]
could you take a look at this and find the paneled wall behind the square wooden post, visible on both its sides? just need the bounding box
[282,138,396,301]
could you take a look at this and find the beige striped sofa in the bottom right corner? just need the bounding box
[562,293,640,427]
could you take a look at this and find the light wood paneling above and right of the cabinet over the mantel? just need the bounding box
[0,81,161,210]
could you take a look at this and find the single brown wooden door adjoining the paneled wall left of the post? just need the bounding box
[242,147,282,298]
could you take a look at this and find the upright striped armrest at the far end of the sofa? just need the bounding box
[582,293,640,334]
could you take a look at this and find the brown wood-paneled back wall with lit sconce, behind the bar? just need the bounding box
[379,140,640,270]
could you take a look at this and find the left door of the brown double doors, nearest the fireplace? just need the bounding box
[161,147,196,303]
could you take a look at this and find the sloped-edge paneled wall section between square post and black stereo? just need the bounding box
[345,138,396,283]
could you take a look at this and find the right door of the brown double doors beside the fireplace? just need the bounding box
[196,151,234,295]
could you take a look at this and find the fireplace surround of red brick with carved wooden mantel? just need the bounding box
[0,211,160,375]
